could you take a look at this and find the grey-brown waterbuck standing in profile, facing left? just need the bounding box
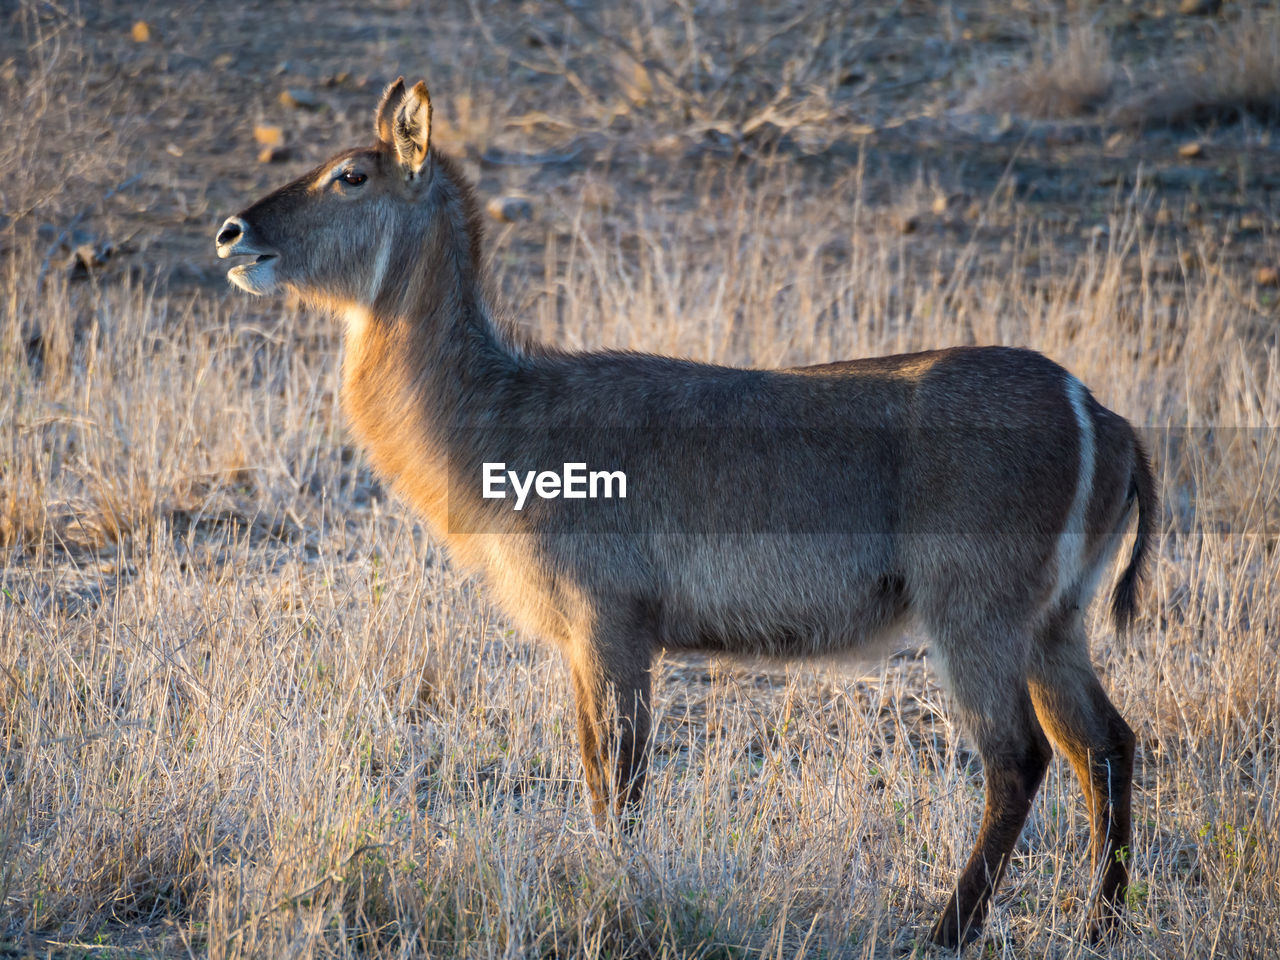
[216,79,1156,946]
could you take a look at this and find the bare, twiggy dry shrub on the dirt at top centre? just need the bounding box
[470,0,878,150]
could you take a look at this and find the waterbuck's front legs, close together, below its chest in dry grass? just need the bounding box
[572,645,650,828]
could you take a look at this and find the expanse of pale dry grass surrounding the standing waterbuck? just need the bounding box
[0,1,1280,957]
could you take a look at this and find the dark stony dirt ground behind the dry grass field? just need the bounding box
[0,0,1280,307]
